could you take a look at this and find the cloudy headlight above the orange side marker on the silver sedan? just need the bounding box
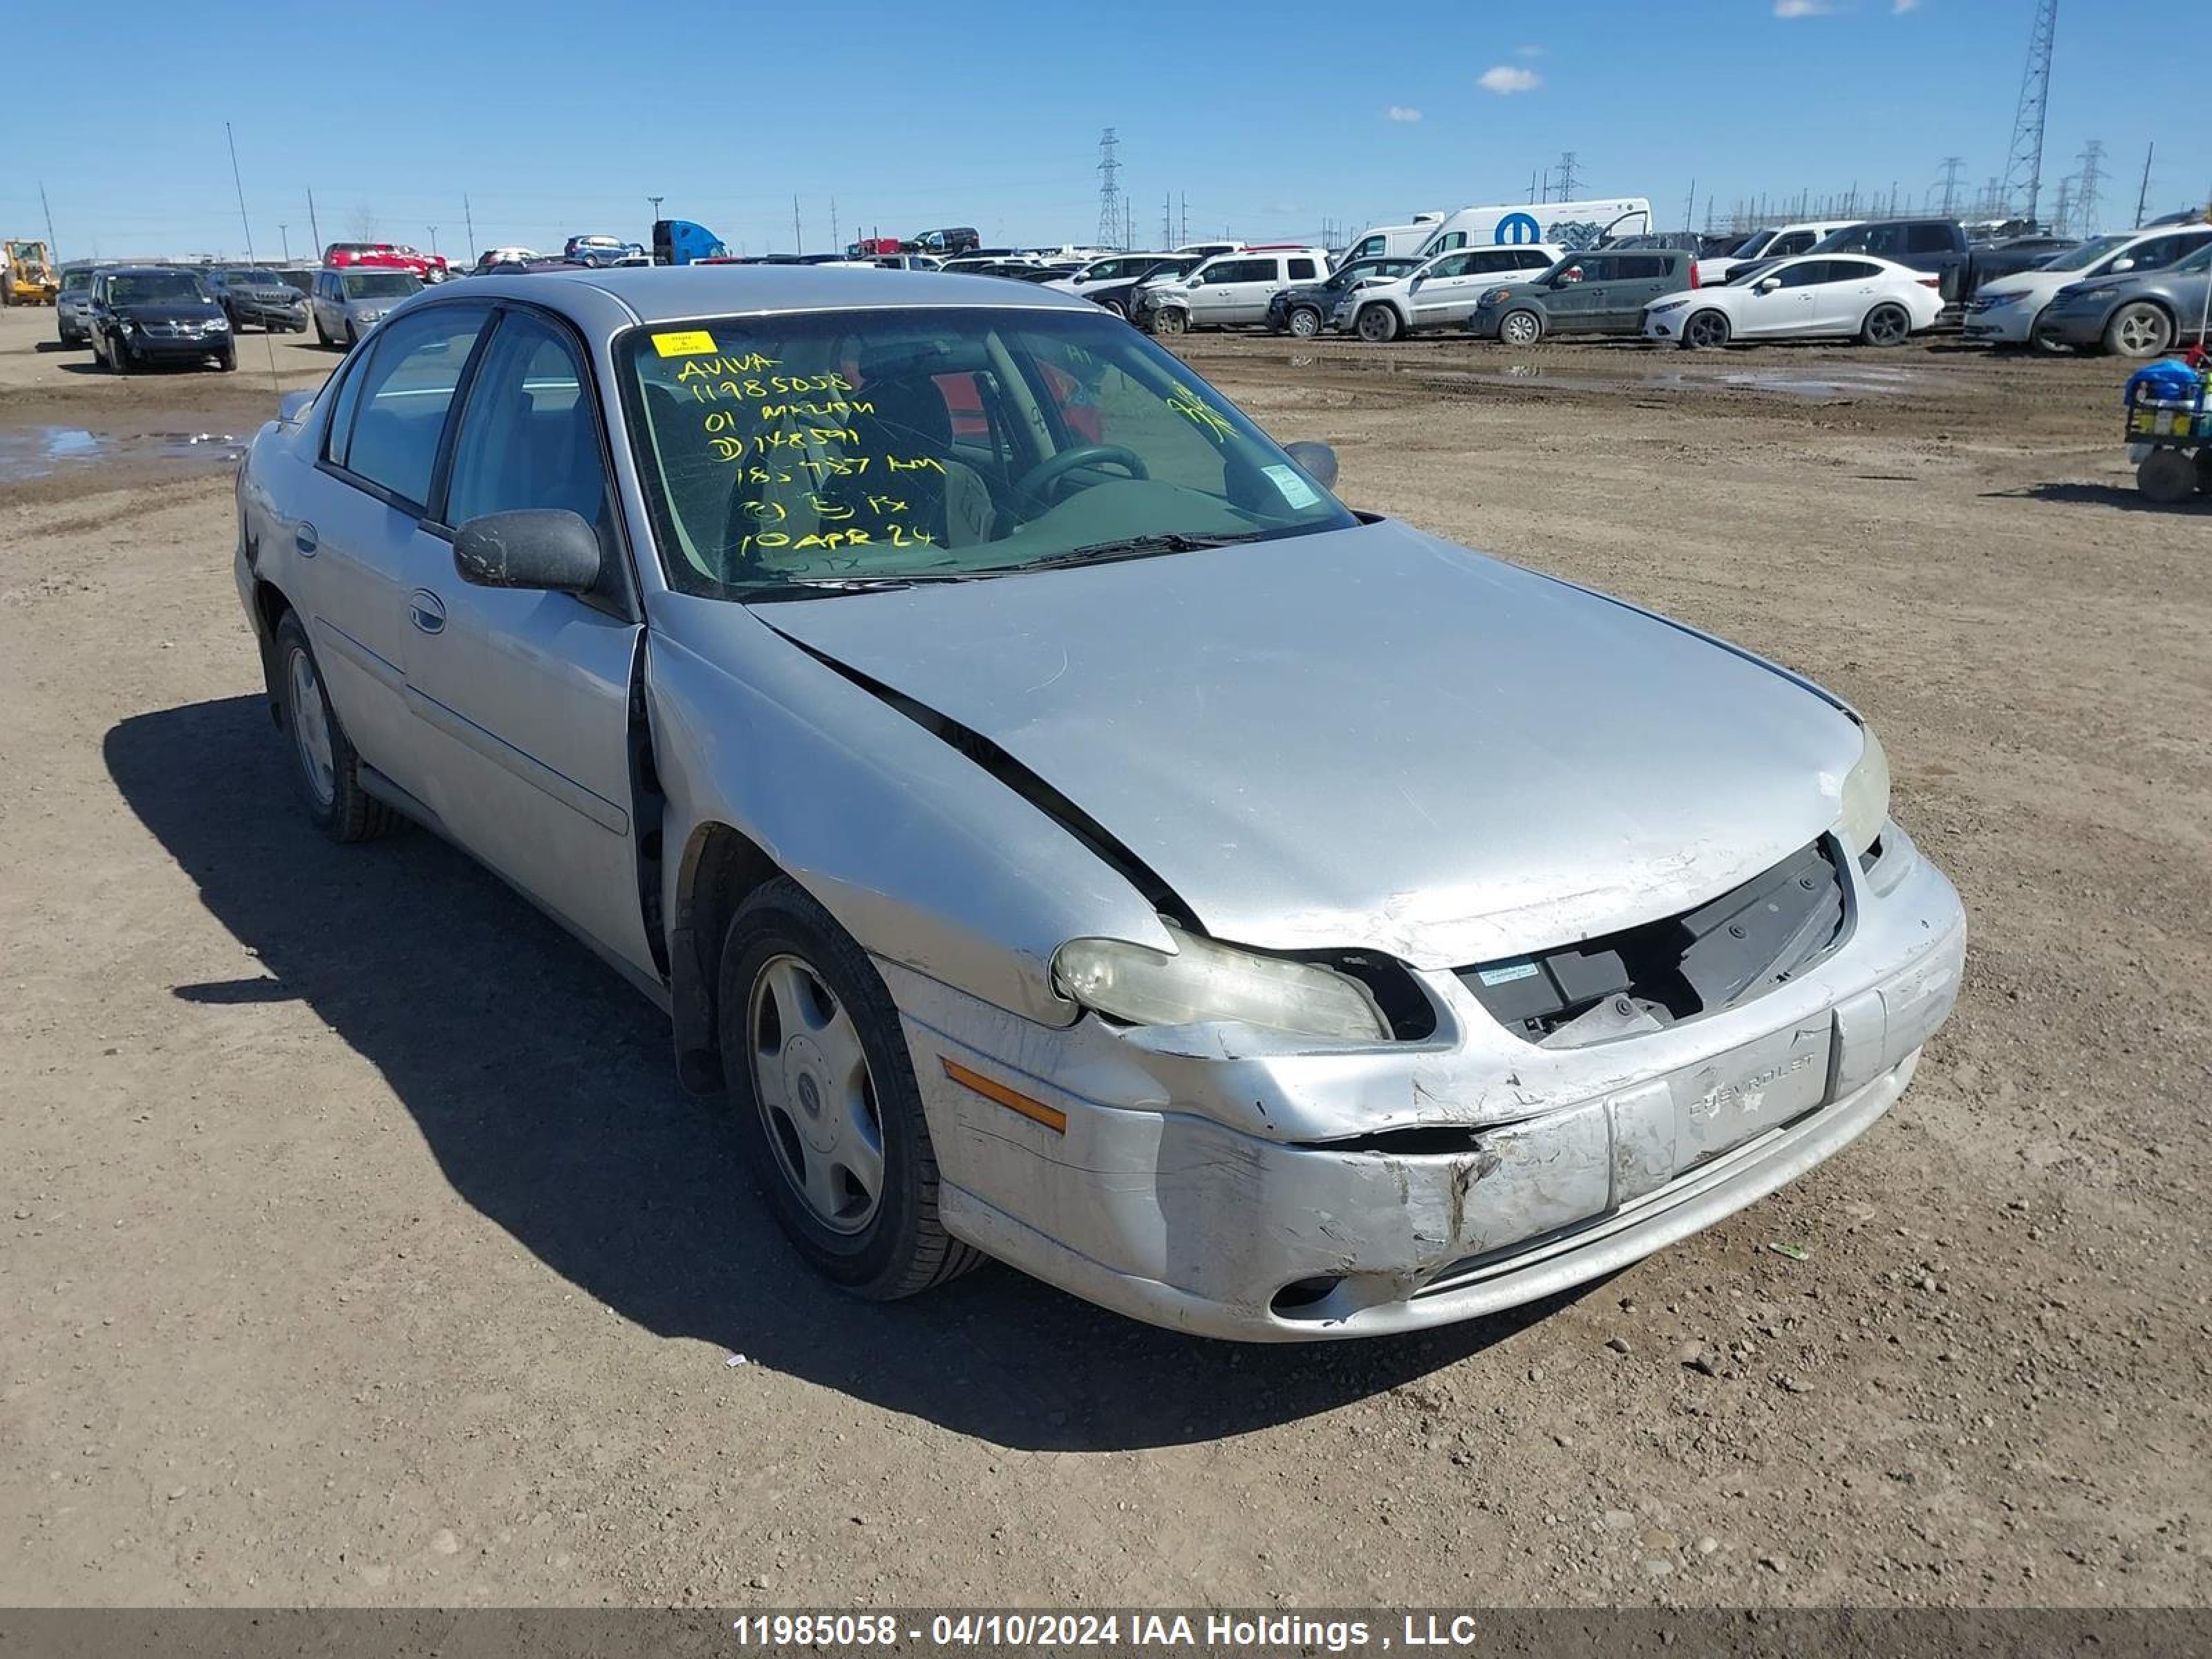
[1053,929,1391,1042]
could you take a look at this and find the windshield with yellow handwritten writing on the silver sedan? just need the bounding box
[617,308,1356,599]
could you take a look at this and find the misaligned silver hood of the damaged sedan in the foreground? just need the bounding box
[752,522,1862,969]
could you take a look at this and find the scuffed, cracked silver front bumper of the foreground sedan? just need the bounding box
[883,825,1967,1340]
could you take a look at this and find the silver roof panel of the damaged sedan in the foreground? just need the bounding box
[404,265,1097,332]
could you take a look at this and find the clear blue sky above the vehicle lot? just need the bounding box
[0,0,2212,256]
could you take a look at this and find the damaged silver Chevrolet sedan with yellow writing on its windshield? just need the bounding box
[236,268,1965,1340]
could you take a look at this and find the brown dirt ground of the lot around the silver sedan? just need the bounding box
[0,299,2212,1606]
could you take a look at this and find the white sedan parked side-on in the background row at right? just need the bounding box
[1644,254,1942,347]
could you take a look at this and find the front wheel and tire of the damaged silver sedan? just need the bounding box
[717,881,982,1301]
